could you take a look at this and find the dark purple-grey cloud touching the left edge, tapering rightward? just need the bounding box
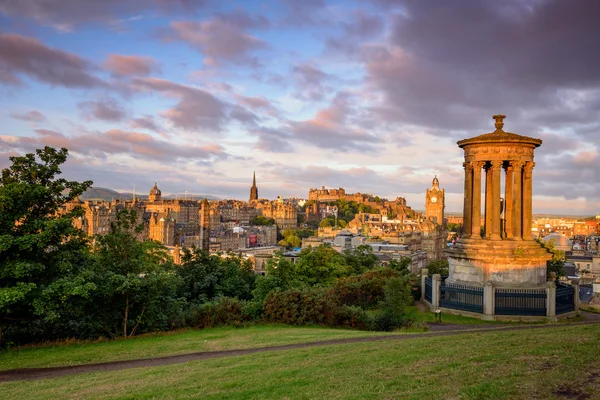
[0,33,105,88]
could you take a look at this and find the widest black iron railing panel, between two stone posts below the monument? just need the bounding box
[495,288,546,316]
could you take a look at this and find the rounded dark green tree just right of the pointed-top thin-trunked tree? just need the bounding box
[176,248,255,303]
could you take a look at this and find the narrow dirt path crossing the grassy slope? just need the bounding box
[0,320,600,382]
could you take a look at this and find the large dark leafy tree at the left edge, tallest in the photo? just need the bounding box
[0,146,92,344]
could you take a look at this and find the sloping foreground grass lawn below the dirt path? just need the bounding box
[0,325,600,399]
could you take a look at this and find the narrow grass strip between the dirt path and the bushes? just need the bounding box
[0,325,408,370]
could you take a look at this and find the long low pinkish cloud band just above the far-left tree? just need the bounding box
[0,129,227,163]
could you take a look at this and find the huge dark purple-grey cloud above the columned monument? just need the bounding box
[362,0,600,135]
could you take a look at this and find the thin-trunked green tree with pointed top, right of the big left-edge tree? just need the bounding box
[93,210,183,337]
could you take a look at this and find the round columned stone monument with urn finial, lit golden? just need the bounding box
[446,115,552,288]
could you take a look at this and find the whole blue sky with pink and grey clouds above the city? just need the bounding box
[0,0,600,215]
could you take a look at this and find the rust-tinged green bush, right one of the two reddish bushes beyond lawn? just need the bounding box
[331,268,399,309]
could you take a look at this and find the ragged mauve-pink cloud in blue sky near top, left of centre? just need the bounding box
[164,15,269,66]
